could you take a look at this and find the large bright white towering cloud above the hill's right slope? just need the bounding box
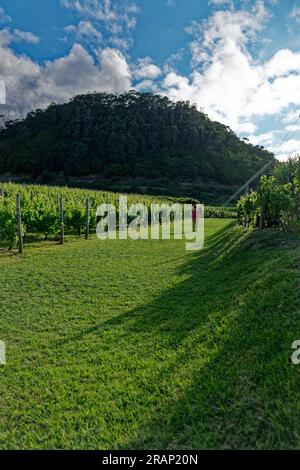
[162,0,300,151]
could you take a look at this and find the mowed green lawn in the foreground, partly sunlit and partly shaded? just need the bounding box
[0,220,300,449]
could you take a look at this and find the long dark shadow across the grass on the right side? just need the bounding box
[60,226,300,449]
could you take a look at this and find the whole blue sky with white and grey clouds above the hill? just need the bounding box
[0,0,300,159]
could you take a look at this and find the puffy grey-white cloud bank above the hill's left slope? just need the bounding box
[0,42,131,118]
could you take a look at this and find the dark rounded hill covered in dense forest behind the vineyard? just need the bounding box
[0,91,273,185]
